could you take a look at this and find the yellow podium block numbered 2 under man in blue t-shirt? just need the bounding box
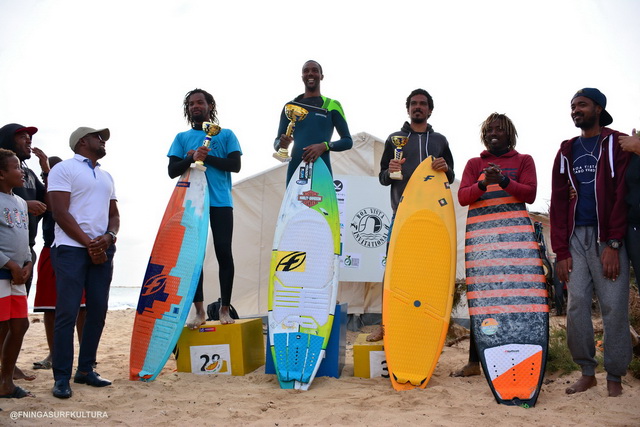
[176,319,264,376]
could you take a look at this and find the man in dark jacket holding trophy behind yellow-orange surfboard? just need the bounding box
[367,89,455,341]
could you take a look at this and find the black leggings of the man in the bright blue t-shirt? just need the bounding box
[193,207,235,306]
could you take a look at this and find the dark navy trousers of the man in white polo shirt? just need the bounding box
[51,245,116,381]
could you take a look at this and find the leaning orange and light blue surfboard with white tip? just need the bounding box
[129,168,209,381]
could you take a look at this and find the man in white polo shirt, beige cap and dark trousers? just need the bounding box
[48,127,120,399]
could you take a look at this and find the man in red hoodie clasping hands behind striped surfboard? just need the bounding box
[451,113,538,377]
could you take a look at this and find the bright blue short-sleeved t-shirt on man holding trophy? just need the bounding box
[167,129,242,208]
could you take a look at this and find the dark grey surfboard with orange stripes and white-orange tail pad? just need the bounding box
[465,181,549,406]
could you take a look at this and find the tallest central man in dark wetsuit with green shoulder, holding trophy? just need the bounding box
[273,60,353,184]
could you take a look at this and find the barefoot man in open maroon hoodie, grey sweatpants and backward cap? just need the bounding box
[550,88,632,397]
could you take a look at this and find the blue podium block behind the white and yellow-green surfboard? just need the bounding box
[264,302,348,378]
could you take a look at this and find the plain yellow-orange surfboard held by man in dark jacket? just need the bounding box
[382,157,456,390]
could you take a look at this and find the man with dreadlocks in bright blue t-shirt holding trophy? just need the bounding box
[168,89,242,329]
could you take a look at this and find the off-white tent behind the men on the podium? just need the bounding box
[204,132,467,317]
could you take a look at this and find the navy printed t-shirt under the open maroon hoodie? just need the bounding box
[572,135,600,226]
